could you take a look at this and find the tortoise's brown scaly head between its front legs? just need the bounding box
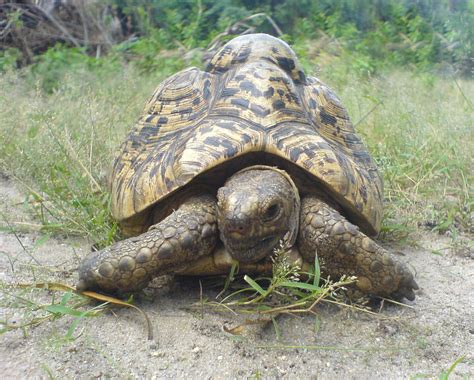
[217,166,300,263]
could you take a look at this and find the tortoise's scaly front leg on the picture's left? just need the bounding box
[76,195,218,294]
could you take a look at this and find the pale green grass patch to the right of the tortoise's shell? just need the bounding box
[336,72,474,238]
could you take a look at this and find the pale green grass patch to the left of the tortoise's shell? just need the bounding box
[0,65,167,246]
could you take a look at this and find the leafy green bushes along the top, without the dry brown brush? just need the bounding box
[0,0,474,81]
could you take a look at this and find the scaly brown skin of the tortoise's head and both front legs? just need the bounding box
[77,167,418,300]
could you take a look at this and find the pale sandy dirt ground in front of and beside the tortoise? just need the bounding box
[0,176,474,379]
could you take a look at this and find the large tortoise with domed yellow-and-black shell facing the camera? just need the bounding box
[77,34,418,300]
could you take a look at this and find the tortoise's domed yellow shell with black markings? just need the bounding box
[111,34,383,238]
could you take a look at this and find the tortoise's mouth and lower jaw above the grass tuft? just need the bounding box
[224,235,280,263]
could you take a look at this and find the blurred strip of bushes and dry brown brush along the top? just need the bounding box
[0,0,474,91]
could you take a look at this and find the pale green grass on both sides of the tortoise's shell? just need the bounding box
[0,52,474,246]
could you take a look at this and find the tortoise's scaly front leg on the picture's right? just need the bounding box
[298,196,418,300]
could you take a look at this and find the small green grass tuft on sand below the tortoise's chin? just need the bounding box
[200,242,371,320]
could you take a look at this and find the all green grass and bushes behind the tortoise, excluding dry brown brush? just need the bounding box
[0,0,474,246]
